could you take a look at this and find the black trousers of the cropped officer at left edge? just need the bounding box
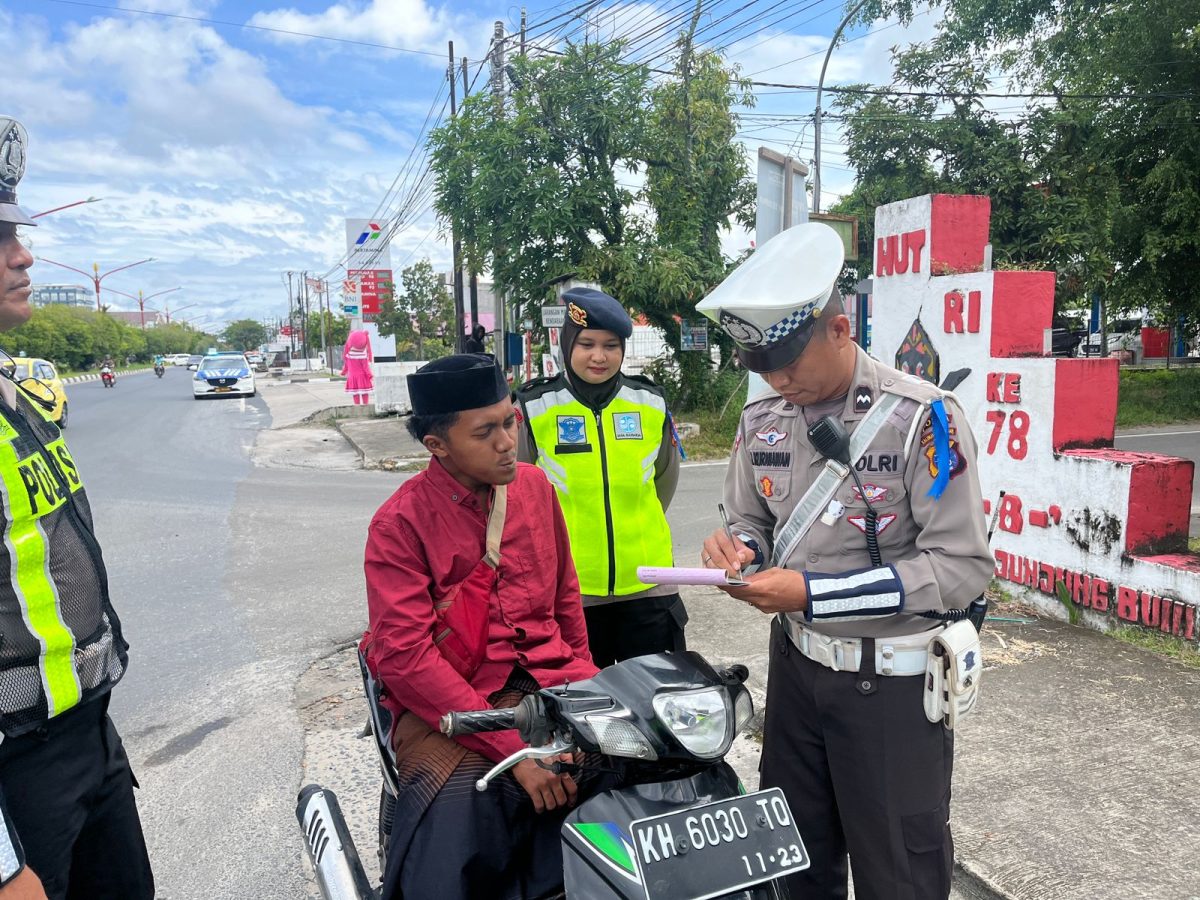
[0,695,154,900]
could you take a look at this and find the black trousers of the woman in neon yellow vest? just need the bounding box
[583,594,688,668]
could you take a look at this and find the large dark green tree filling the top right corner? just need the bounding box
[864,0,1200,320]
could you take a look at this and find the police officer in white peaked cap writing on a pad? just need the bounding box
[697,223,994,900]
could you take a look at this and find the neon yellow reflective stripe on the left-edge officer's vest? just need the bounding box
[0,420,83,716]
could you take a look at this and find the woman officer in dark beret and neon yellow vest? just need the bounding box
[516,287,688,667]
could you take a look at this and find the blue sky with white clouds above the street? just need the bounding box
[9,0,935,329]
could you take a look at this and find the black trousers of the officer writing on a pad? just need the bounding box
[762,623,954,900]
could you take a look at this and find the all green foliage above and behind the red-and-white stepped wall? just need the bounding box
[845,0,1200,322]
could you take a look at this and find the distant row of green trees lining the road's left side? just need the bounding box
[2,304,212,370]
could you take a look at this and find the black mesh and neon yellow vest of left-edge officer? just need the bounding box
[0,392,128,737]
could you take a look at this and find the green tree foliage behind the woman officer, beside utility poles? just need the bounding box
[430,36,754,401]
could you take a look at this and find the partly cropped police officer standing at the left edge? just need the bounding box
[0,118,154,900]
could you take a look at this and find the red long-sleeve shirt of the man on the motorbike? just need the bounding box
[366,458,598,762]
